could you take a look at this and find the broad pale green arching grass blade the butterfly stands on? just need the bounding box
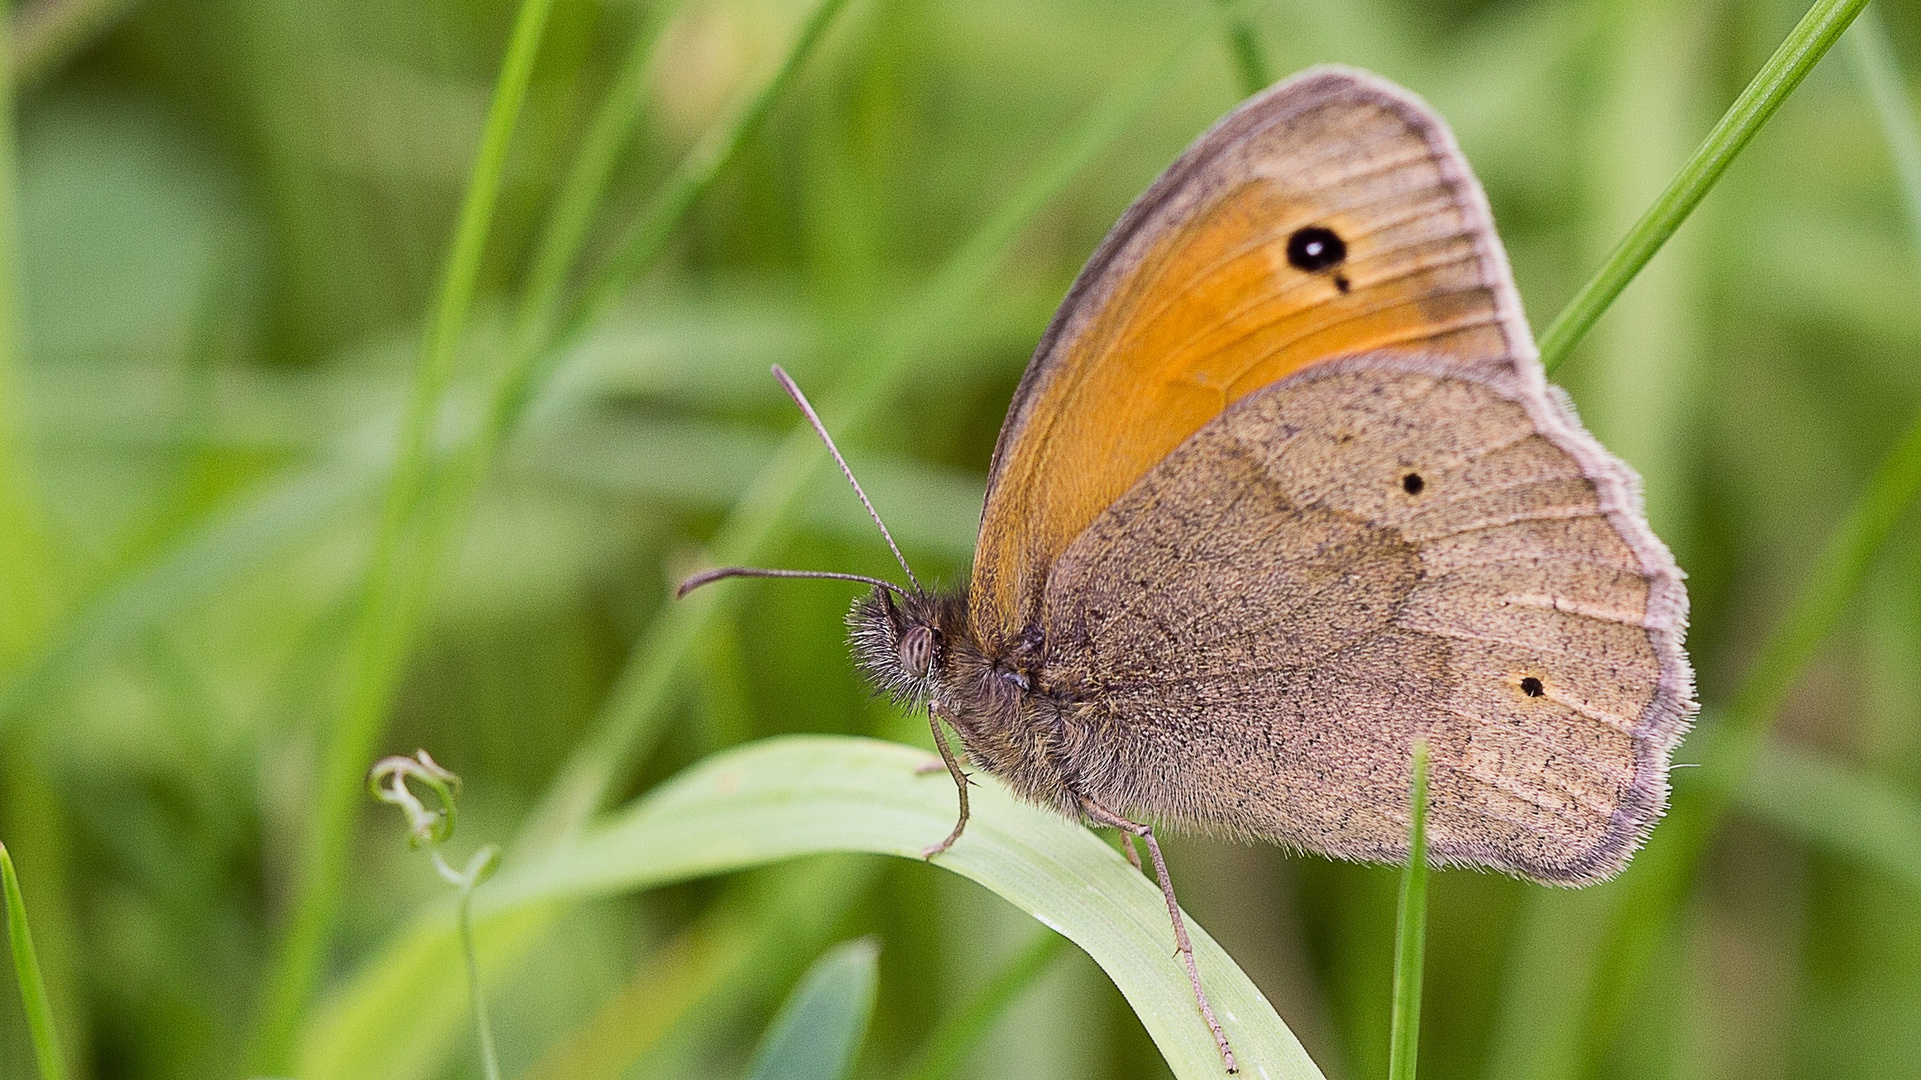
[484,736,1320,1080]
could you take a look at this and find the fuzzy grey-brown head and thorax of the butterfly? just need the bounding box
[847,588,1089,813]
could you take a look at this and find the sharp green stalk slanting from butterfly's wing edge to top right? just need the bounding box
[1541,0,1867,373]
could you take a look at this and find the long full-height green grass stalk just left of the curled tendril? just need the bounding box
[254,0,553,1072]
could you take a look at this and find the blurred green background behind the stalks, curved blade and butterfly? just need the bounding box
[0,0,1921,1080]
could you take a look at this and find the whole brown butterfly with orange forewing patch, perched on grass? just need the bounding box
[682,67,1694,1072]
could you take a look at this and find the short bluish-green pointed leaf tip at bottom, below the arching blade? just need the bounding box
[747,938,880,1080]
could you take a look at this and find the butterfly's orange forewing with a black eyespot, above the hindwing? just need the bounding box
[970,69,1533,640]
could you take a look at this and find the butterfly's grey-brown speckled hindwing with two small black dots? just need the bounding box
[1039,354,1692,884]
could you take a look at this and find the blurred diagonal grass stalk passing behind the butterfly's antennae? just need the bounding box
[517,38,1193,849]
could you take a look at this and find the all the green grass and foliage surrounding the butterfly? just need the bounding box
[0,0,1921,1080]
